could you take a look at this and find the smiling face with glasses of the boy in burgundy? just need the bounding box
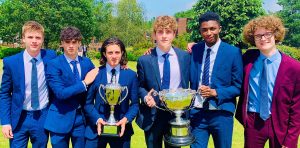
[254,28,276,53]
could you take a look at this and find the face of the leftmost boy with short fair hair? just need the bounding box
[22,31,44,56]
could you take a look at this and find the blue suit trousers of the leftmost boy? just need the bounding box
[9,108,49,148]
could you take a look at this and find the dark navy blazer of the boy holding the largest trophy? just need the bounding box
[136,48,190,131]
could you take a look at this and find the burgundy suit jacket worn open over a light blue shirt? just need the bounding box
[236,50,300,148]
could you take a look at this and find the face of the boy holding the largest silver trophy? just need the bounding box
[155,29,175,50]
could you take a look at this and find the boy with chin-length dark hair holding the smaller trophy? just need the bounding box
[84,37,139,148]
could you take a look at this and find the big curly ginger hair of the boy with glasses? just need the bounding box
[243,15,285,46]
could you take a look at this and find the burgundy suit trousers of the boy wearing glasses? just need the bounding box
[244,112,281,148]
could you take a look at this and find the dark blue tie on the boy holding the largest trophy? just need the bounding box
[161,53,170,89]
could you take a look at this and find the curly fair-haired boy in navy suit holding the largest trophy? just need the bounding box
[136,16,190,148]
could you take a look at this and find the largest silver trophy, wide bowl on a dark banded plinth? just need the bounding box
[153,88,197,146]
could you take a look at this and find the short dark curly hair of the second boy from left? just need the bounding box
[60,26,82,41]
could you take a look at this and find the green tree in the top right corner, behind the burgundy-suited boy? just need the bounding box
[278,0,300,47]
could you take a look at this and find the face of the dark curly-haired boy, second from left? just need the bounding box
[61,39,81,59]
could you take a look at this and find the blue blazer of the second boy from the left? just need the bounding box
[44,55,94,133]
